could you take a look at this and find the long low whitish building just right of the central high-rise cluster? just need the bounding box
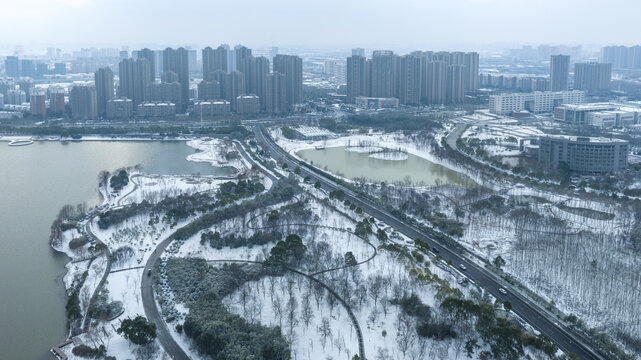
[490,90,585,115]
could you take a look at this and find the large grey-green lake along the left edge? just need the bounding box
[0,142,231,360]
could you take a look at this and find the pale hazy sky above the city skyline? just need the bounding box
[0,0,641,49]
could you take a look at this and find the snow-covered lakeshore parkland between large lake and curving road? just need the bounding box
[52,139,260,359]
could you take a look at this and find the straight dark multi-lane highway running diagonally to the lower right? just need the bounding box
[254,126,608,360]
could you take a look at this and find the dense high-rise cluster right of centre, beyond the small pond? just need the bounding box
[346,49,479,105]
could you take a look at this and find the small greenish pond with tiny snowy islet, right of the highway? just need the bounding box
[298,146,473,186]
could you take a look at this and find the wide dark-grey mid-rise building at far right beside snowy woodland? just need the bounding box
[539,135,629,174]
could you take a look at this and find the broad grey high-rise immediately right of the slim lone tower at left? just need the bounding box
[118,58,151,107]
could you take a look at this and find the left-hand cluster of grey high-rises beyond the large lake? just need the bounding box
[0,45,303,119]
